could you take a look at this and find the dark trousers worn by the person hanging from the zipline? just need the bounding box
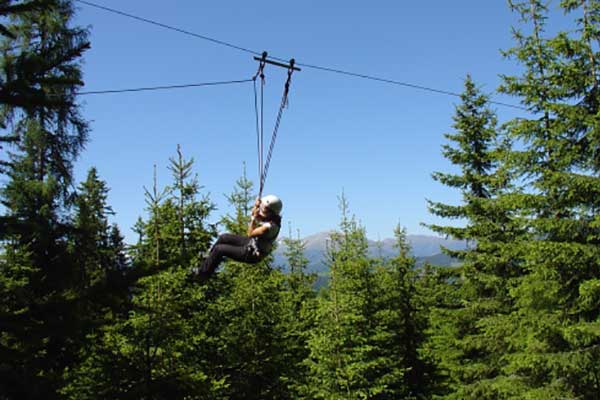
[200,233,261,277]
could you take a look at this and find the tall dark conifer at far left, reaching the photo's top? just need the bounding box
[0,0,89,398]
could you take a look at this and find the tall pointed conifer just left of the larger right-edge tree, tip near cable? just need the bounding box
[429,76,520,399]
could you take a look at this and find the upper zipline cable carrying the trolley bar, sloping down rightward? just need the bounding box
[74,0,527,111]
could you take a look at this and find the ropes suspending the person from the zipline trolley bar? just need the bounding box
[252,52,299,198]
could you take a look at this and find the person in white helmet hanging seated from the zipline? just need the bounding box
[192,195,283,280]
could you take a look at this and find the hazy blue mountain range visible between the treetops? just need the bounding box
[275,231,466,273]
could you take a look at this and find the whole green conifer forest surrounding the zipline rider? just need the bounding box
[0,0,600,400]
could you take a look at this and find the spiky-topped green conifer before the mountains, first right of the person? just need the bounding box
[304,196,404,399]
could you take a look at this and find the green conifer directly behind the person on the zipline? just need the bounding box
[209,167,287,399]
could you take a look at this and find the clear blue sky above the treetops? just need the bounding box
[71,0,556,241]
